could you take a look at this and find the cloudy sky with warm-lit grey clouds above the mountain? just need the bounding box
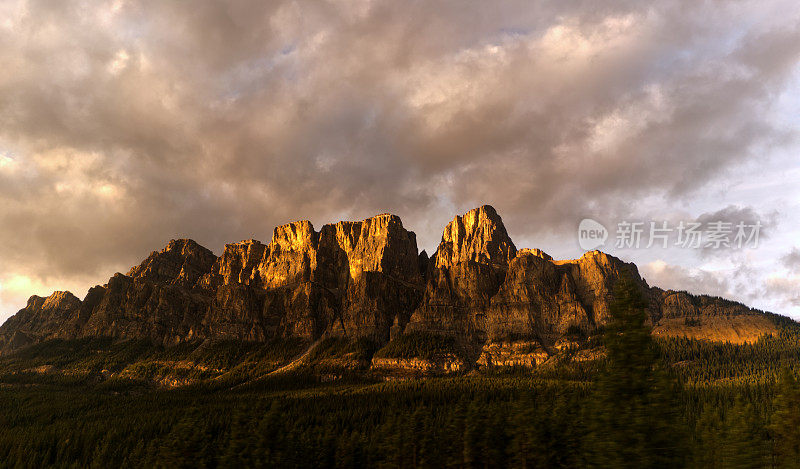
[0,0,800,321]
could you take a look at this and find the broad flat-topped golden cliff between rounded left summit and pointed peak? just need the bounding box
[194,214,422,341]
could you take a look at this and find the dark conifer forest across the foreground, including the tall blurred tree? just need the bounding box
[0,283,800,468]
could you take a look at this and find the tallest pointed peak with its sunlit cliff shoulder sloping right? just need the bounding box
[408,206,645,346]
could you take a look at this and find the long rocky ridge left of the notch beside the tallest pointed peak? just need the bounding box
[0,214,424,349]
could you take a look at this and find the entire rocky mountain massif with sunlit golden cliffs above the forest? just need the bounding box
[0,206,777,354]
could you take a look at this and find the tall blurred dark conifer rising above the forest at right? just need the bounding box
[586,276,684,468]
